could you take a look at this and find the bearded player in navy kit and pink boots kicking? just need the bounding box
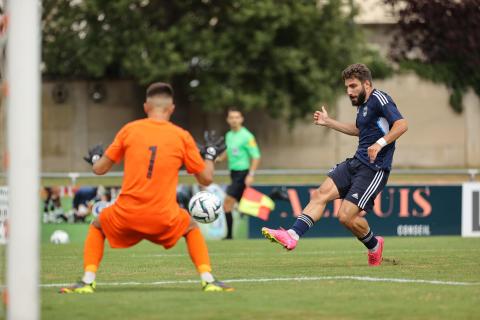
[262,64,408,266]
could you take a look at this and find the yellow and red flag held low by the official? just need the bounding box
[238,188,275,221]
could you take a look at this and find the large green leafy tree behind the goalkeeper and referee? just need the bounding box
[43,0,389,120]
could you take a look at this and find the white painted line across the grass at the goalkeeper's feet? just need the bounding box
[40,276,480,288]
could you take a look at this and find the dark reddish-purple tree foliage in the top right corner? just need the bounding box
[385,0,480,112]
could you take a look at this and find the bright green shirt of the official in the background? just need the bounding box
[225,127,260,171]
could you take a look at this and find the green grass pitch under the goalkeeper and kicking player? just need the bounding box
[41,237,480,320]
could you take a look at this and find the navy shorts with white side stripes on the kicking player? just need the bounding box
[328,158,390,211]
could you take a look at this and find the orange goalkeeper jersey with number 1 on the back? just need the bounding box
[105,118,205,222]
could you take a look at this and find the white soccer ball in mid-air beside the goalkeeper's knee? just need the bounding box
[188,191,223,223]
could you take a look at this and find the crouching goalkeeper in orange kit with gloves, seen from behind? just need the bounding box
[60,82,233,293]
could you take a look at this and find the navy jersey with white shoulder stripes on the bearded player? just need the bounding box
[355,89,403,171]
